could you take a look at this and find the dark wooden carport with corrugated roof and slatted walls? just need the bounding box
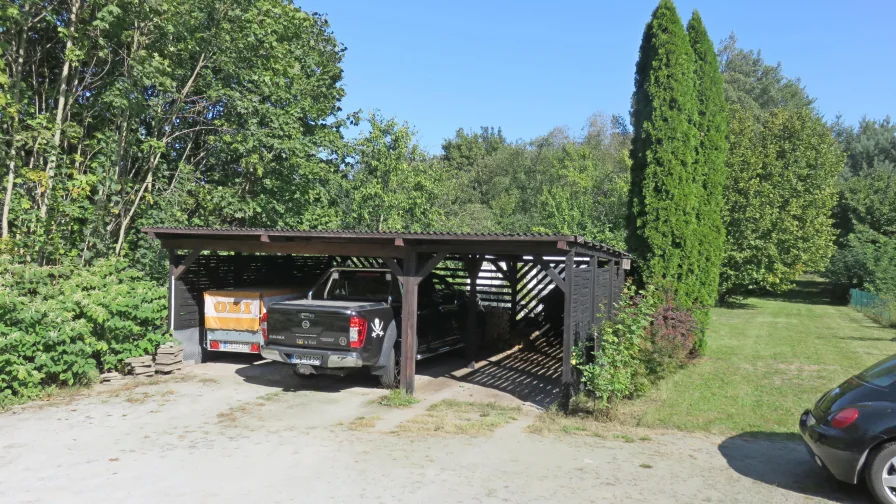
[143,227,631,398]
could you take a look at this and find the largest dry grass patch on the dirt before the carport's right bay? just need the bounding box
[397,399,522,436]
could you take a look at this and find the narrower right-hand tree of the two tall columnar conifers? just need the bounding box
[687,10,728,350]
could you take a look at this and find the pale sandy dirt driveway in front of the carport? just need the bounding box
[0,355,870,504]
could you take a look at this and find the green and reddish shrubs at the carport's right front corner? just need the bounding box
[573,284,701,409]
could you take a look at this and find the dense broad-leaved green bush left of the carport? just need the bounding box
[0,260,169,404]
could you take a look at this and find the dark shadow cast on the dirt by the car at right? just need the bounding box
[719,432,873,504]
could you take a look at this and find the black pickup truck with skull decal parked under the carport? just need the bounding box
[261,268,482,388]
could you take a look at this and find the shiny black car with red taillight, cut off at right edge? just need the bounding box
[800,355,896,504]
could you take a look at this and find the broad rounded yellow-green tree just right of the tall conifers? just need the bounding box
[720,106,843,298]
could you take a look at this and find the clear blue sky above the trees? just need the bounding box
[297,0,896,152]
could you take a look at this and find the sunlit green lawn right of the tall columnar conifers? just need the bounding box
[619,279,896,434]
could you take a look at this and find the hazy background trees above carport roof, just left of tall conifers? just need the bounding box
[426,114,629,248]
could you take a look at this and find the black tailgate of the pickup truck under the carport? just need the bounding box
[268,300,385,350]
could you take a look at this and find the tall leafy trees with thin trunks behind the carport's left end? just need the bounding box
[0,0,353,264]
